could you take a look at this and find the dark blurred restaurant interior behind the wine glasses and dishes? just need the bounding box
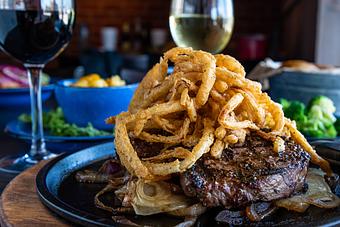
[0,0,334,77]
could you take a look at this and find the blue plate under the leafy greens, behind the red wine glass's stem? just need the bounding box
[5,120,113,153]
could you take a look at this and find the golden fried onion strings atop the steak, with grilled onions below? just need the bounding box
[88,47,339,225]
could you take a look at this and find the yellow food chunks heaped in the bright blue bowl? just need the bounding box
[72,74,126,87]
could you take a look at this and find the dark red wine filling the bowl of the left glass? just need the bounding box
[0,10,74,64]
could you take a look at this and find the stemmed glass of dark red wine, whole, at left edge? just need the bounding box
[0,0,75,172]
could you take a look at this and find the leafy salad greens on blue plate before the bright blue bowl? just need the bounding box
[19,108,110,136]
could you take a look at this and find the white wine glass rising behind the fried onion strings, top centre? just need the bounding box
[169,0,234,53]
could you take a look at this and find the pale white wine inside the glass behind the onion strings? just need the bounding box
[169,14,234,53]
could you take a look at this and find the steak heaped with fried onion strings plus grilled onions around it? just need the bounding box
[37,48,340,226]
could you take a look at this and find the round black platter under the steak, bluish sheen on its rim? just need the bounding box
[36,143,340,226]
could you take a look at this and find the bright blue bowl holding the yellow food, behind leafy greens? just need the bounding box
[55,80,138,130]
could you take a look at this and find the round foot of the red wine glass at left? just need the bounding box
[0,153,57,174]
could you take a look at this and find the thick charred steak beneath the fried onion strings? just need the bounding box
[180,134,310,208]
